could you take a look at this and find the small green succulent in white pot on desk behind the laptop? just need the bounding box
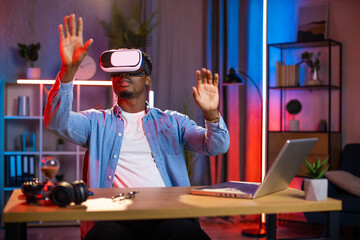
[303,157,329,201]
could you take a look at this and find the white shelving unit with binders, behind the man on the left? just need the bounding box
[0,79,114,214]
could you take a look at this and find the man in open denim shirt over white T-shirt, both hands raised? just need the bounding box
[44,14,230,239]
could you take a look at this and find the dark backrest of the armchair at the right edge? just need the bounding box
[340,143,360,177]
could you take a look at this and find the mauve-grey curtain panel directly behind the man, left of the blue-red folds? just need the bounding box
[144,0,210,185]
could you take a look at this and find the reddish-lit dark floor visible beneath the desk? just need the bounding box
[0,216,359,240]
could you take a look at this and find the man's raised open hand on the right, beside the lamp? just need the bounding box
[193,68,219,121]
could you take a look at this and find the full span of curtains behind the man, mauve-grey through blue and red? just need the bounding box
[144,0,261,185]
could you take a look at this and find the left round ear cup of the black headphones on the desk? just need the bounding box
[50,182,74,207]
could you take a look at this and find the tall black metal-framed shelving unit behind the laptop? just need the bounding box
[266,39,342,176]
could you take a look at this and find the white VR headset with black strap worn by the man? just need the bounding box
[100,49,150,75]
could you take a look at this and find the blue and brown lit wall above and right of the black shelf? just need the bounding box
[268,0,360,145]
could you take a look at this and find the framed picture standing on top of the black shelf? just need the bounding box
[297,5,328,42]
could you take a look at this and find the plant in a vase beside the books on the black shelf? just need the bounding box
[298,51,322,85]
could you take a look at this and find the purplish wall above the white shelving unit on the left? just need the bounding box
[0,0,133,82]
